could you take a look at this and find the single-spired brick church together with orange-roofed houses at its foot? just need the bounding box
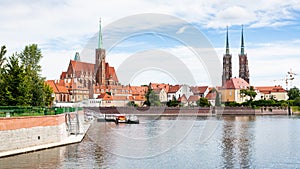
[46,21,147,106]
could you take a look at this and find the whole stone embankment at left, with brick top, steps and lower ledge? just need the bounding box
[0,111,89,157]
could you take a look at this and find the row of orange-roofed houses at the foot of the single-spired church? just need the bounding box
[46,79,148,107]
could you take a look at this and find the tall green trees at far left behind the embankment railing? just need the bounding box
[0,44,53,106]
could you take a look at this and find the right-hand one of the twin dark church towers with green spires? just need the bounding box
[239,26,250,84]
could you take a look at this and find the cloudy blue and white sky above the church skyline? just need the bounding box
[0,0,300,88]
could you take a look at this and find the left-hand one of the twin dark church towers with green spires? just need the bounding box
[222,26,232,86]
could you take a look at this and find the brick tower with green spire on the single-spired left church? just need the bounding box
[95,19,106,85]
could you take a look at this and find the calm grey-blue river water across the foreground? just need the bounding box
[0,116,300,169]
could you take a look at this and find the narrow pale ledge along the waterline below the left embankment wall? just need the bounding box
[0,124,90,157]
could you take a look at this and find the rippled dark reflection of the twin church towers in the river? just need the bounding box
[222,116,255,168]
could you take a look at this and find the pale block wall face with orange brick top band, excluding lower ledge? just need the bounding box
[0,111,84,152]
